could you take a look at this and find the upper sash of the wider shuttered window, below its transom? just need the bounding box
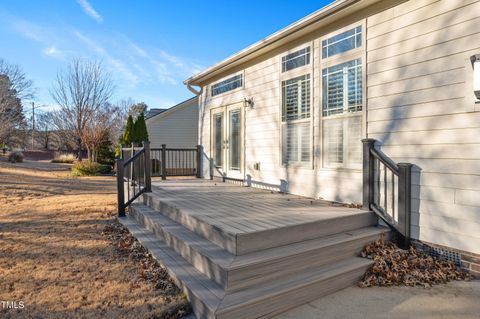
[322,59,363,116]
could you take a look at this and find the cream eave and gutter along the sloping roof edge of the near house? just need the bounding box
[183,0,364,85]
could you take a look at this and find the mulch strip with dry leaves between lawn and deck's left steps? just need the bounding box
[103,222,192,319]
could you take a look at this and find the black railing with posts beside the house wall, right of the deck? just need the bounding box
[362,139,413,248]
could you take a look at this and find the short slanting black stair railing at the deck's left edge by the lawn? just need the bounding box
[116,142,152,217]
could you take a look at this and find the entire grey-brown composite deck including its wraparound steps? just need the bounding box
[124,179,388,319]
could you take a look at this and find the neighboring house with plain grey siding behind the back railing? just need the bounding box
[146,97,198,148]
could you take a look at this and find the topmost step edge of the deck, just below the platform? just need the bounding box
[142,193,377,255]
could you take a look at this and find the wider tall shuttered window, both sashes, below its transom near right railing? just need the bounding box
[322,59,363,168]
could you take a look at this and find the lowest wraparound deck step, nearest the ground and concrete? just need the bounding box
[120,216,371,319]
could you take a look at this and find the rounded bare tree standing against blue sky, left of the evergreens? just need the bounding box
[51,59,113,158]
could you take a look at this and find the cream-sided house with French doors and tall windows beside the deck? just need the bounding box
[186,0,480,264]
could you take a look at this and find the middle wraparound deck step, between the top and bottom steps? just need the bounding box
[130,204,388,291]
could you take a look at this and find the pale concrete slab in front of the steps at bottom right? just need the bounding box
[275,281,480,319]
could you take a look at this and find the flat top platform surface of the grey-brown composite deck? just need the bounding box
[153,180,364,238]
